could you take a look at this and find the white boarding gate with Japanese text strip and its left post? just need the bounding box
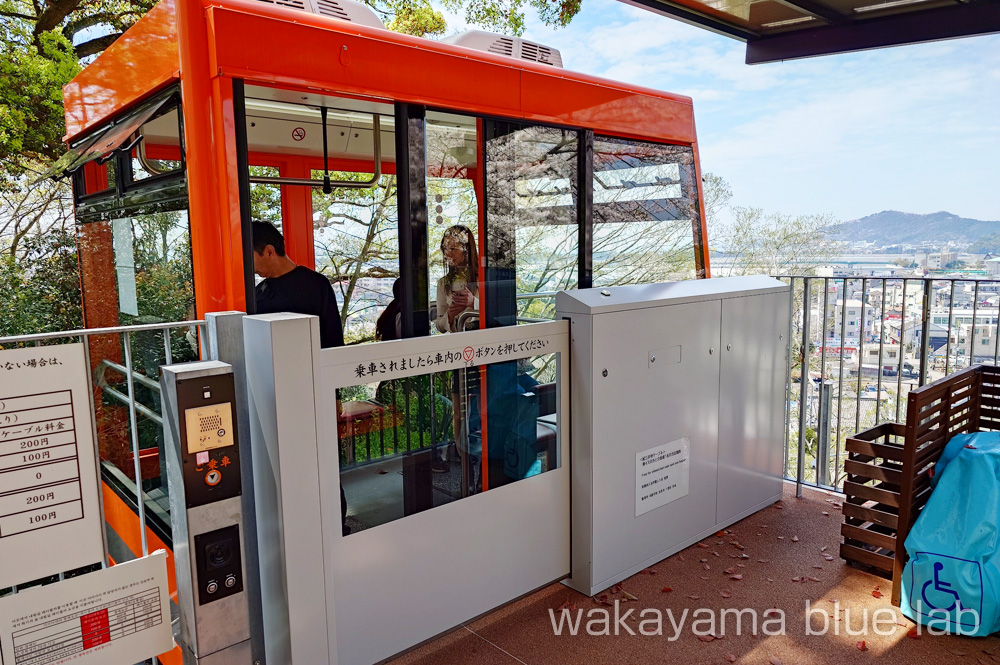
[244,314,570,665]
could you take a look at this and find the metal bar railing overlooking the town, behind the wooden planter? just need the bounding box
[777,275,1000,489]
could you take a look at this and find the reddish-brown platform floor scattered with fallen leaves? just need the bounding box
[392,485,1000,665]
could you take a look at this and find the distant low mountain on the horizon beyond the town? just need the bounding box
[826,210,1000,246]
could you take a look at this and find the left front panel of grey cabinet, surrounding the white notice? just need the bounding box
[592,300,721,588]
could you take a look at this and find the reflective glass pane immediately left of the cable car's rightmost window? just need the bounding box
[486,122,579,325]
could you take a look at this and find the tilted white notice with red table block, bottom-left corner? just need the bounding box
[0,550,174,665]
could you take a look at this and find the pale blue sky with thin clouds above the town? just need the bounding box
[434,0,1000,226]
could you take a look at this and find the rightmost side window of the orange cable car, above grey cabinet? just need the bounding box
[593,136,700,287]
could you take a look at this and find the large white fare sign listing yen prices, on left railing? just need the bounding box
[0,344,104,588]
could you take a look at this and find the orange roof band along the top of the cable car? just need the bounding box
[63,0,696,144]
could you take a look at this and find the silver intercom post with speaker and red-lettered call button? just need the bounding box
[160,360,252,665]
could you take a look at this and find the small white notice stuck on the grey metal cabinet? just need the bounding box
[635,437,691,517]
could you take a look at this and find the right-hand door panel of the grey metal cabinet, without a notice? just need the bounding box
[716,293,789,524]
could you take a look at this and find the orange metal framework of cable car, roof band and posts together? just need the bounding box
[64,0,709,652]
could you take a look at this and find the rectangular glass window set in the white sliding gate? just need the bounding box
[337,354,561,533]
